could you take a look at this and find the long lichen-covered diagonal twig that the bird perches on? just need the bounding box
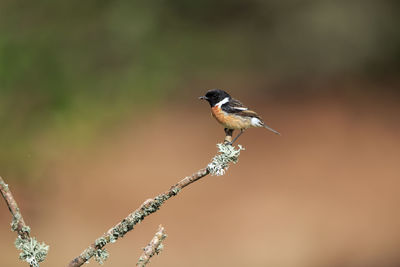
[68,144,243,267]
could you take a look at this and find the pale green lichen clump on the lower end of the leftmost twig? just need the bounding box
[15,236,49,267]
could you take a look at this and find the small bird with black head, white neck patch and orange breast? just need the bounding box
[199,89,281,145]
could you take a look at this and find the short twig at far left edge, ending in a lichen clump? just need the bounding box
[0,176,49,267]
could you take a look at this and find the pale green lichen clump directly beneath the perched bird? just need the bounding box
[207,144,244,176]
